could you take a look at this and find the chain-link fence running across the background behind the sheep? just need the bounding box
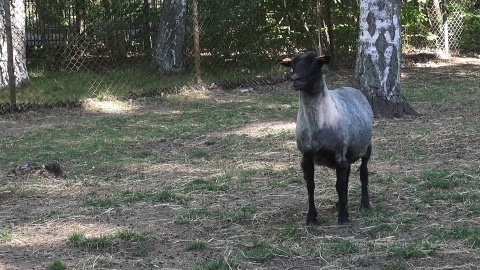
[0,0,476,113]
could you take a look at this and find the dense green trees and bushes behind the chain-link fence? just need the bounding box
[19,0,480,67]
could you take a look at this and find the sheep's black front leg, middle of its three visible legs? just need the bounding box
[335,162,350,224]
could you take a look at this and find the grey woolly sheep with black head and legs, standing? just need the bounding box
[280,52,373,225]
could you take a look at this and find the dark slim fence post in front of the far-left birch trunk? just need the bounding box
[3,0,17,106]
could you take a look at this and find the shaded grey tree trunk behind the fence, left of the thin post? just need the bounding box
[153,0,187,72]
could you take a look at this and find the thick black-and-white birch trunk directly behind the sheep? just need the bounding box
[354,0,416,117]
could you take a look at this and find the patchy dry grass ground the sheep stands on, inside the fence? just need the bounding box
[0,60,480,269]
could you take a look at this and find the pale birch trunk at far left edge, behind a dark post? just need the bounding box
[0,0,29,87]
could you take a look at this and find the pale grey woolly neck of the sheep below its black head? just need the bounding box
[299,77,338,128]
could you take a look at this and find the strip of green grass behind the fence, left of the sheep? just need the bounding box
[0,59,278,104]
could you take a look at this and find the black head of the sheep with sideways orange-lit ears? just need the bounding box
[280,52,330,91]
